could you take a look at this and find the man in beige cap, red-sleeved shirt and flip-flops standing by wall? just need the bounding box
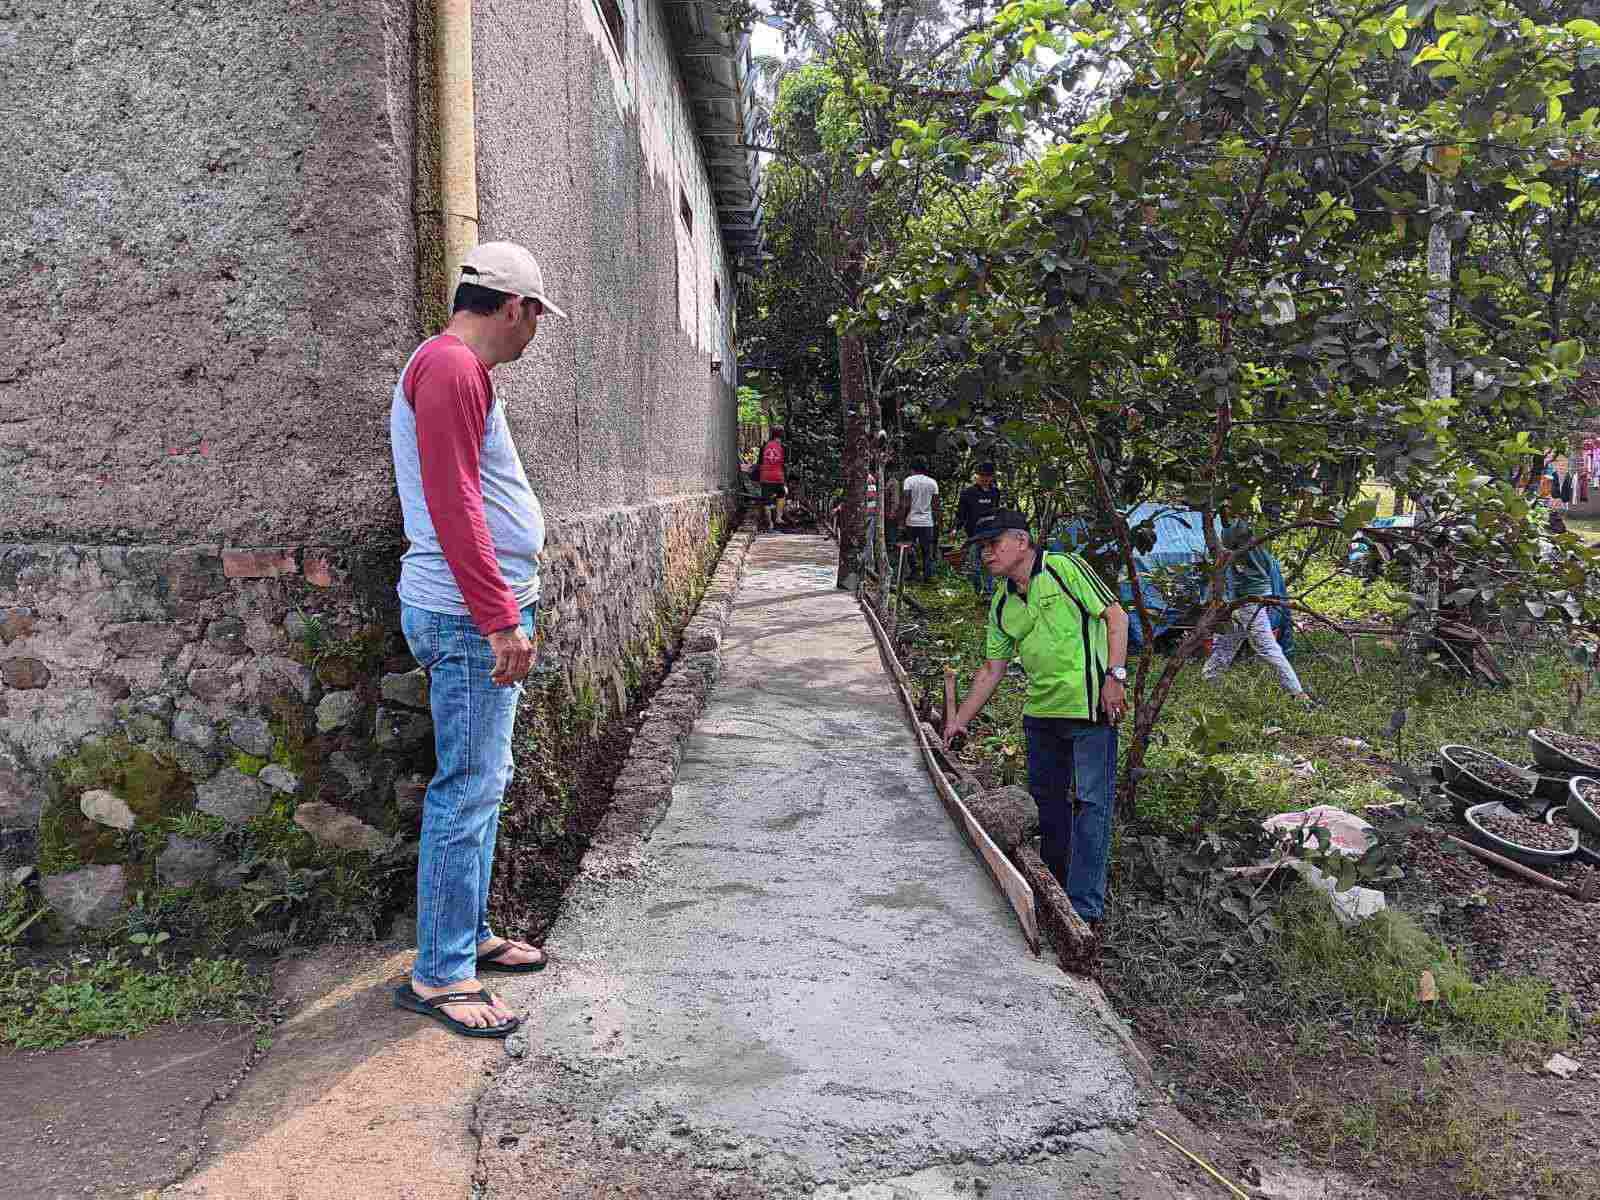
[389,242,566,1037]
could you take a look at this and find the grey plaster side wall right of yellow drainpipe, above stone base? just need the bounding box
[474,0,736,517]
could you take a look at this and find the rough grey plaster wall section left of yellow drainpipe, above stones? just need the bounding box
[0,0,416,544]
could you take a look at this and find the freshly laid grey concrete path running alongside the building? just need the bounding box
[477,536,1145,1200]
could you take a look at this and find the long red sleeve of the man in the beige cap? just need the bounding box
[405,338,522,637]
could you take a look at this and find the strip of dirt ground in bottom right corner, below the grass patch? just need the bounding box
[1133,1010,1600,1200]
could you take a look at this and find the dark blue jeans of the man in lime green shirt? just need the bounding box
[1022,717,1117,922]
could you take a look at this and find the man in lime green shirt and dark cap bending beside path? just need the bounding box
[944,509,1128,928]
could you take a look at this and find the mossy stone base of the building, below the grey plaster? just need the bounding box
[0,493,733,928]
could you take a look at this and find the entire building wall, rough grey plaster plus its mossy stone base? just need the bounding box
[0,0,736,928]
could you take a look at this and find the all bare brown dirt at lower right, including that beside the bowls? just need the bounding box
[1120,809,1600,1200]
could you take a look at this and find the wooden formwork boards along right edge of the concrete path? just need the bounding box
[858,597,1154,1083]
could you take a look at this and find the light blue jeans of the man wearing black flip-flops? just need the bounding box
[400,605,538,987]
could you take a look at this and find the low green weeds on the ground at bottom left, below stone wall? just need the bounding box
[0,947,262,1050]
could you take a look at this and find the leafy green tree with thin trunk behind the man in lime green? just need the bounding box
[854,0,1600,803]
